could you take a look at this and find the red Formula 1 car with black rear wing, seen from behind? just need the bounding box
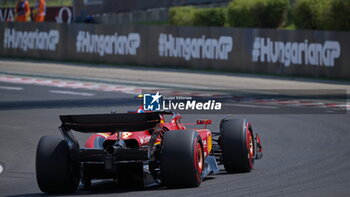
[36,111,262,193]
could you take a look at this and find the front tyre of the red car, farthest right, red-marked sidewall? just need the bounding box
[220,118,255,173]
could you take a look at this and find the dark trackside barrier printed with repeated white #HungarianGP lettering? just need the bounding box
[0,23,350,79]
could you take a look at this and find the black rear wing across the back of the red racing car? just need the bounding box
[60,111,170,133]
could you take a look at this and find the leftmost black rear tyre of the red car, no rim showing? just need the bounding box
[35,136,80,193]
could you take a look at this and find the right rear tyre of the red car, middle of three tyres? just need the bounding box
[160,130,204,187]
